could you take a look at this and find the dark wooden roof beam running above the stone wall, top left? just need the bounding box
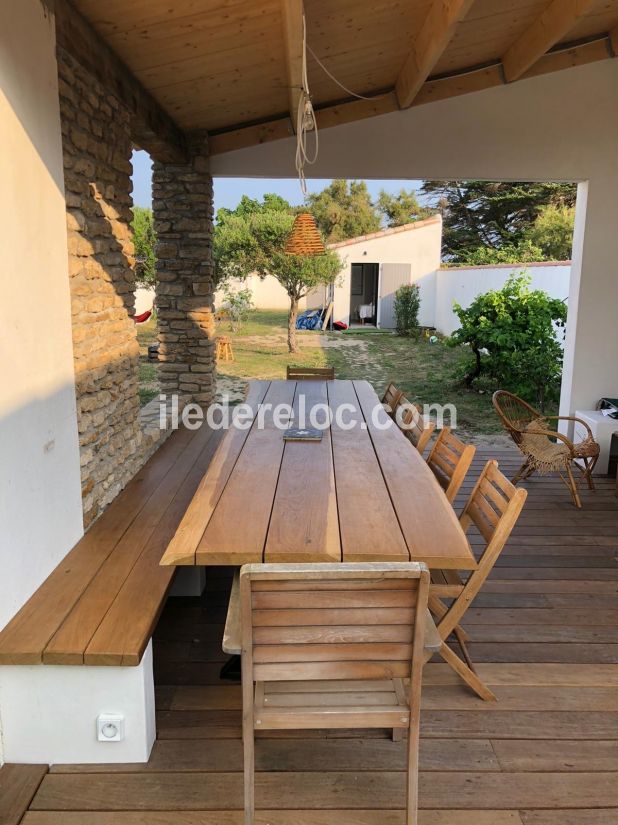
[54,0,188,163]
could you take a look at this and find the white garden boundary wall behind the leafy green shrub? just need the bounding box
[430,263,571,335]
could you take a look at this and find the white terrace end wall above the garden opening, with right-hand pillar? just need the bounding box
[211,60,618,412]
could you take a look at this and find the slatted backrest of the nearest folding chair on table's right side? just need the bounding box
[459,461,528,552]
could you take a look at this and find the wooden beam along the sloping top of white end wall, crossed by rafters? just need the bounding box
[209,37,618,155]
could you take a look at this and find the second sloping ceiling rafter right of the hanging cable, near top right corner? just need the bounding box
[502,0,597,83]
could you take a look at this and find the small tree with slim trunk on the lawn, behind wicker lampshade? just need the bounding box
[214,195,342,352]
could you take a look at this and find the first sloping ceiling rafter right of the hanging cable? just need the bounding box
[395,0,473,109]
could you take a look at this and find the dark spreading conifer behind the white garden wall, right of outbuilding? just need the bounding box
[421,180,576,263]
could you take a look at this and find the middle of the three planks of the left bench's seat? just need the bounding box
[43,418,217,665]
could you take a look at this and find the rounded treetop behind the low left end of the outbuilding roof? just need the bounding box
[307,180,381,243]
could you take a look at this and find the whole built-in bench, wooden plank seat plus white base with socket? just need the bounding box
[0,418,221,763]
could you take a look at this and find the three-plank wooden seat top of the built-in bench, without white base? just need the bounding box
[0,426,219,666]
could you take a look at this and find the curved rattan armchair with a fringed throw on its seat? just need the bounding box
[493,390,599,507]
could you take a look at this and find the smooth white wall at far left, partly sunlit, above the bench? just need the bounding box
[0,0,83,644]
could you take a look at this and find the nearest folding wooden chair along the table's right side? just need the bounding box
[429,461,528,700]
